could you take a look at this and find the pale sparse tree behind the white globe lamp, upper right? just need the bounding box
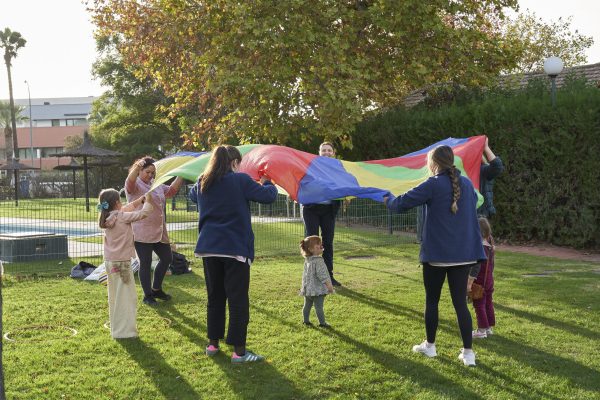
[506,10,594,72]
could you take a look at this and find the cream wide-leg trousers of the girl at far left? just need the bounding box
[105,261,138,339]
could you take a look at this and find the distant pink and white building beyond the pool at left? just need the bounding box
[0,96,96,169]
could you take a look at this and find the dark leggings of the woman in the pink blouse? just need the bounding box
[134,242,173,296]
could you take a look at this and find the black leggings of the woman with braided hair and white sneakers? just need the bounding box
[423,263,473,349]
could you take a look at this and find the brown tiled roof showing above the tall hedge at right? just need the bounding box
[402,63,600,108]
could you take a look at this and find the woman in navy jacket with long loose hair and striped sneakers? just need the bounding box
[189,146,277,363]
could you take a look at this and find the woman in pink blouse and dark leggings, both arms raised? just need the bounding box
[125,156,183,305]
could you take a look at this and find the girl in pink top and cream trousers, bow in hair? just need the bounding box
[98,189,152,339]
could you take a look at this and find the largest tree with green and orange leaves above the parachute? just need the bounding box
[88,0,519,145]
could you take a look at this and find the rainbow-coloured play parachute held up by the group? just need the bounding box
[153,135,485,204]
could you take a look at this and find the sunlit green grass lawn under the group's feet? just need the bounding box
[3,245,600,400]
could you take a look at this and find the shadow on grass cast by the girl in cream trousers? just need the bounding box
[117,338,201,399]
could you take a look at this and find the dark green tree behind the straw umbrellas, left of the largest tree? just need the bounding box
[91,36,182,159]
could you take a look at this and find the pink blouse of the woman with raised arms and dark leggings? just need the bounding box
[125,177,177,243]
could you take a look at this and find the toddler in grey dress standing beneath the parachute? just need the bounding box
[300,236,333,328]
